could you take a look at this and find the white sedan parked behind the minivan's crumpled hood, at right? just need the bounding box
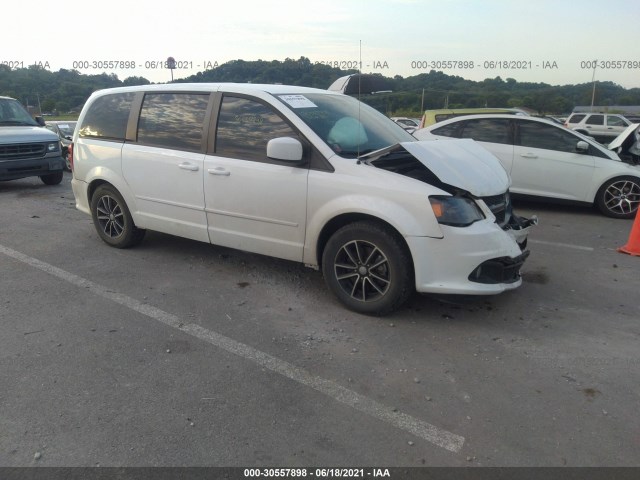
[414,115,640,218]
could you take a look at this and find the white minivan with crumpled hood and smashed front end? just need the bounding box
[72,83,533,314]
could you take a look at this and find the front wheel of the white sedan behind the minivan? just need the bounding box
[596,176,640,218]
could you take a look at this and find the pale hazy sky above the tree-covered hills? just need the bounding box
[0,0,640,88]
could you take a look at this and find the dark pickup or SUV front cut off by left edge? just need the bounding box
[0,97,64,185]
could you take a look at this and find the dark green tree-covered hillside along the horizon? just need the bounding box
[0,57,640,116]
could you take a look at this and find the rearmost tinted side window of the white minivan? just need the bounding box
[79,92,135,141]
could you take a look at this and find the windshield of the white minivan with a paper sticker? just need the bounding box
[277,93,416,158]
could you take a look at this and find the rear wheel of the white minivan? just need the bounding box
[91,185,145,248]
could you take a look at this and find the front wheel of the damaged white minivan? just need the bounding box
[322,222,414,315]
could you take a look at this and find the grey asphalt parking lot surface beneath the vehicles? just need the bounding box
[0,173,640,467]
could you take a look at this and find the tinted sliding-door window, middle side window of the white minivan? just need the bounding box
[138,93,209,152]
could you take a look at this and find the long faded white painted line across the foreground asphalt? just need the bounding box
[0,245,465,453]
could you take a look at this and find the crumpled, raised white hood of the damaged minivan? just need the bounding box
[399,139,511,197]
